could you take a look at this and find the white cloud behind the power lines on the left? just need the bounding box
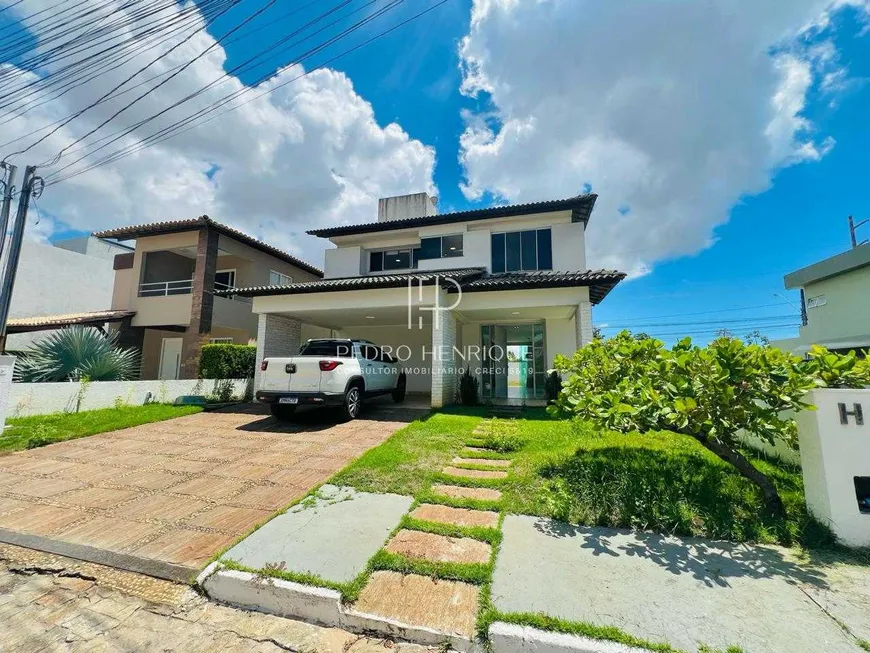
[0,0,435,264]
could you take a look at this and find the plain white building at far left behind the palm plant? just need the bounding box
[5,236,132,351]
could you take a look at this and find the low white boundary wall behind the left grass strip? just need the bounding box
[6,379,247,418]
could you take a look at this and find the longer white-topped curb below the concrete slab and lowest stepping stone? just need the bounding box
[196,562,480,653]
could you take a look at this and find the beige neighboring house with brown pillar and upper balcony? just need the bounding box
[94,216,323,379]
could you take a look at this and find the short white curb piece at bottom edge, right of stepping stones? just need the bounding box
[489,621,649,653]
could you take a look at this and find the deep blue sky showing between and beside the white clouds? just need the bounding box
[218,0,870,341]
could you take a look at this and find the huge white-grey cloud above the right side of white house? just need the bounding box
[460,0,868,274]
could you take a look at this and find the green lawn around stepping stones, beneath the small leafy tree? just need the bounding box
[332,408,834,548]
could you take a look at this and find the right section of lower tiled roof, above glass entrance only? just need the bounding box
[449,270,625,304]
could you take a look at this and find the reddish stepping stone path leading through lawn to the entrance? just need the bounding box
[354,419,516,640]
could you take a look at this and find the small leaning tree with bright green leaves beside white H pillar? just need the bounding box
[551,332,870,512]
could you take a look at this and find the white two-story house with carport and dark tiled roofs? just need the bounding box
[219,193,625,407]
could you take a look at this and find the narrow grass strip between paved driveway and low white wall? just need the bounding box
[0,404,202,453]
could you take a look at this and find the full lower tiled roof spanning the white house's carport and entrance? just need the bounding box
[215,268,625,304]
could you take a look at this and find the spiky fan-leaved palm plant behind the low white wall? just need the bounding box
[15,325,139,383]
